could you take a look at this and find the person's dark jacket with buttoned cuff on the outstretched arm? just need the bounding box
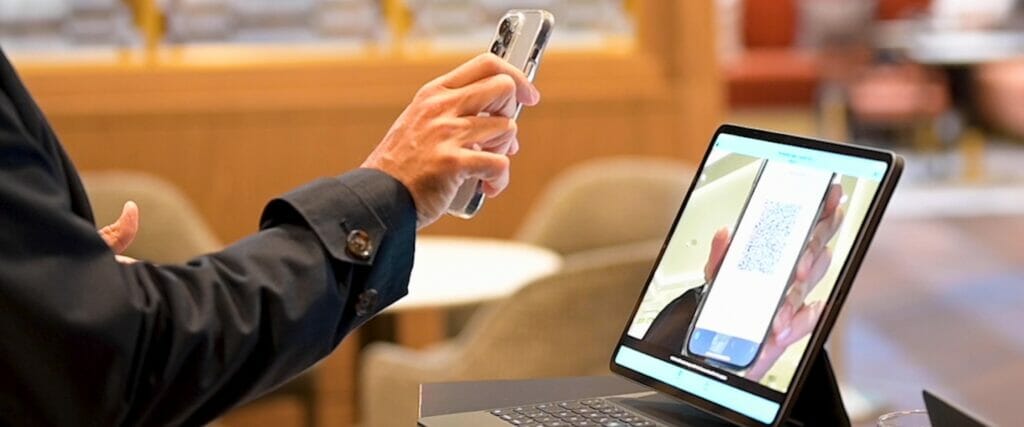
[0,105,416,425]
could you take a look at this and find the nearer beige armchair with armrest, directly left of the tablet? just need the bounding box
[359,245,659,427]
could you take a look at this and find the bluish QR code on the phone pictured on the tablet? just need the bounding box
[739,201,800,274]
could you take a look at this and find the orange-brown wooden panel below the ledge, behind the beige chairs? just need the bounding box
[53,96,686,241]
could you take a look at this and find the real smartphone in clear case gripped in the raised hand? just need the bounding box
[447,9,555,218]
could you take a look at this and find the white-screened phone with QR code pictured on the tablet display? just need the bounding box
[686,160,836,369]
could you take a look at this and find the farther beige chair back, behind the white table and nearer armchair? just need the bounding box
[516,157,694,256]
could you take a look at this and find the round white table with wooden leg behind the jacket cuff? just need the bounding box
[384,237,562,348]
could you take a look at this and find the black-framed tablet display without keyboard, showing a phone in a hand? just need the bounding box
[613,124,892,424]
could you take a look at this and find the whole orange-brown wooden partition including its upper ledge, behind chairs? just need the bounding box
[25,49,686,242]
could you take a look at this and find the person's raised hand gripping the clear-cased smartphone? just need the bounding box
[362,53,541,228]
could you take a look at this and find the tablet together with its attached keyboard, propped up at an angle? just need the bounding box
[419,125,903,427]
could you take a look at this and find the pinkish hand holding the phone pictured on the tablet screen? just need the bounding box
[705,183,843,381]
